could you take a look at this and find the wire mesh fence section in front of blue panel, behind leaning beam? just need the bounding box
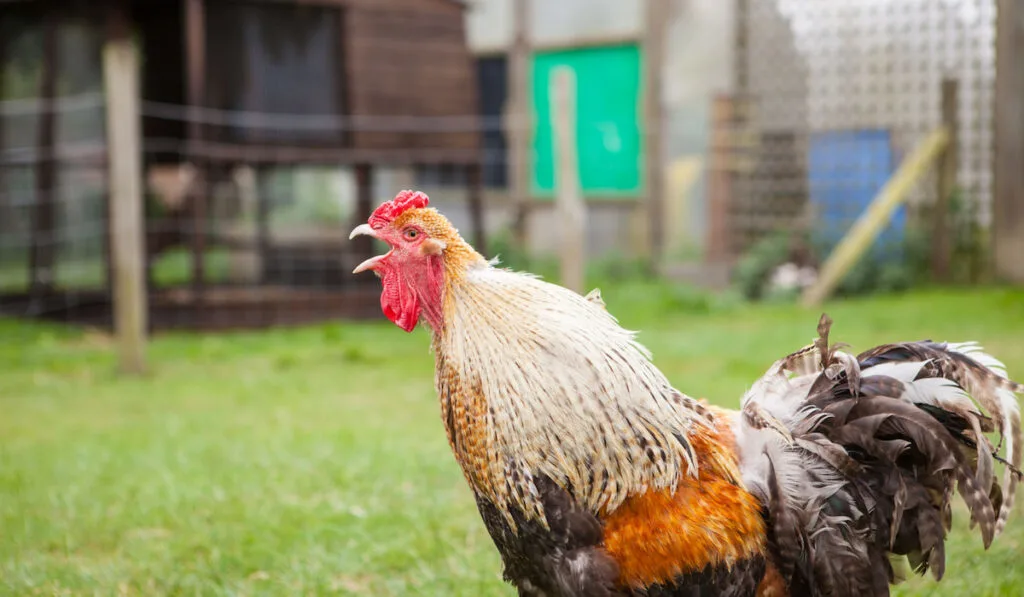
[722,0,995,276]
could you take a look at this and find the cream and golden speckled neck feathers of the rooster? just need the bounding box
[434,263,699,518]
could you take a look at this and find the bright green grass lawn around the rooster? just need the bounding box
[0,285,1024,597]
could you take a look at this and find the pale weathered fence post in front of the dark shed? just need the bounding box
[103,2,146,374]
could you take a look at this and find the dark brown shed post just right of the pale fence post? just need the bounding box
[184,0,210,301]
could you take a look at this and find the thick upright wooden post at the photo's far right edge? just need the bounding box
[992,0,1024,283]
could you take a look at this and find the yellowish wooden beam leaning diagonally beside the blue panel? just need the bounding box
[803,127,949,306]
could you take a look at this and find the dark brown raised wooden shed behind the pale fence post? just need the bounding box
[0,0,483,328]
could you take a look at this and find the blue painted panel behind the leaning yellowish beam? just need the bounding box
[807,130,906,256]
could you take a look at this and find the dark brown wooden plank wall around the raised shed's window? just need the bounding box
[16,0,481,164]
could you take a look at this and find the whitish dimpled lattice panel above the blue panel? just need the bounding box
[746,0,995,224]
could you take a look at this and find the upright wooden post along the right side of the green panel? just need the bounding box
[641,0,670,264]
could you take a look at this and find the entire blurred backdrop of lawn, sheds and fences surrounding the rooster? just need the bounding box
[0,0,1024,595]
